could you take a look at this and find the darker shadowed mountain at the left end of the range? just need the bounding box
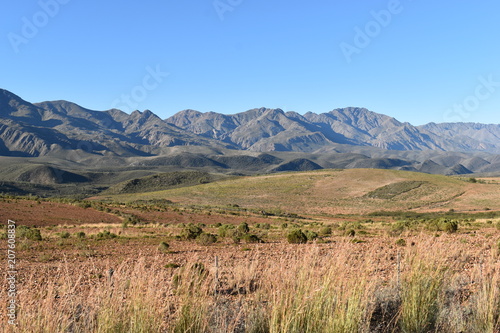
[0,90,232,156]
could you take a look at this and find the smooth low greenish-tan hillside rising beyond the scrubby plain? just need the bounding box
[97,169,500,215]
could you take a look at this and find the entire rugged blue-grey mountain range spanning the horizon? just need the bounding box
[0,89,500,188]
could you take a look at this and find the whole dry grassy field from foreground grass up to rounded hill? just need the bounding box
[0,169,500,333]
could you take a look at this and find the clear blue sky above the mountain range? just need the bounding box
[0,0,500,125]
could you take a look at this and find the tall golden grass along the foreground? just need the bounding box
[0,235,500,333]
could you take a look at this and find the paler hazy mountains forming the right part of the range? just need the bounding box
[166,108,500,153]
